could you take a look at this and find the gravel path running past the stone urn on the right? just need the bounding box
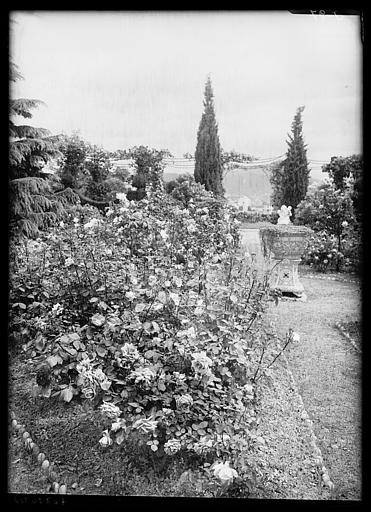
[271,277,361,500]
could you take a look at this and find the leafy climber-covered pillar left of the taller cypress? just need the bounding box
[128,146,171,201]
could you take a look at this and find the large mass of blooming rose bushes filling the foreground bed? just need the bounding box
[10,191,282,486]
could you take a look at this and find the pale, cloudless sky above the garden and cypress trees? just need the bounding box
[10,11,362,176]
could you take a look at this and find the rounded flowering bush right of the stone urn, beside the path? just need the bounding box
[295,181,361,271]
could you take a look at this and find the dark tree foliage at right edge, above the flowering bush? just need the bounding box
[322,155,363,221]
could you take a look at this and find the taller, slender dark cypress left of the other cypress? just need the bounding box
[194,77,224,196]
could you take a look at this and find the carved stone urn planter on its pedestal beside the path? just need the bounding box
[259,224,312,300]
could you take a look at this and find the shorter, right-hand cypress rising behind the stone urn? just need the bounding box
[271,107,310,216]
